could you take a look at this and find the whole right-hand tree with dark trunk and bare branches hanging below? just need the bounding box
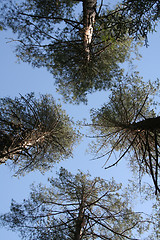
[91,75,160,194]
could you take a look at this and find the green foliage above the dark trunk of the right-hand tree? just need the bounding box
[91,72,158,134]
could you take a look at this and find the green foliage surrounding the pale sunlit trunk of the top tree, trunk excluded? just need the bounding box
[1,0,144,103]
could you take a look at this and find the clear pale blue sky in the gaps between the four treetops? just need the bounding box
[0,13,160,240]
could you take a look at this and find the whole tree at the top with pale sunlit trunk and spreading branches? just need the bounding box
[0,0,159,103]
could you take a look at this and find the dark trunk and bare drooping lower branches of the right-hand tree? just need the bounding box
[107,116,160,195]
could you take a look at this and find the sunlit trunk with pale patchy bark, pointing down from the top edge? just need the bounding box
[83,0,97,62]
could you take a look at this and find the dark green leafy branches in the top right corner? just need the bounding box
[100,0,160,45]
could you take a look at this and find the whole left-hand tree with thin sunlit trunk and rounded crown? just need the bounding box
[0,93,77,173]
